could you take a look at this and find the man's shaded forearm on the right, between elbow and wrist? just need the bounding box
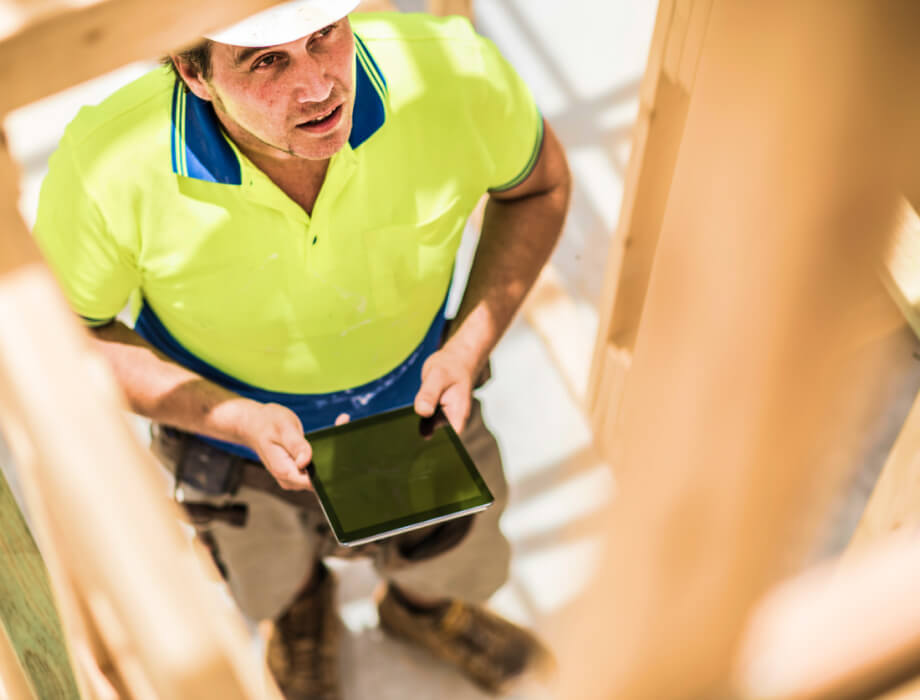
[450,179,569,369]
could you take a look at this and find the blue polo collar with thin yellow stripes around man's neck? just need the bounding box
[171,34,388,185]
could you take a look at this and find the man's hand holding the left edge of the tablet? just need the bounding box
[243,402,313,491]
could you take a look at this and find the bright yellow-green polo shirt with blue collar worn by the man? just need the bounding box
[35,13,542,442]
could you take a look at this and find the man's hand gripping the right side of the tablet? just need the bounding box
[415,341,479,434]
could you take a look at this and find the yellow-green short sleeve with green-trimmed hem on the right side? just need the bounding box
[476,38,543,192]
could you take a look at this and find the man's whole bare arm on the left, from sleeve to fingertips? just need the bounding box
[92,321,311,489]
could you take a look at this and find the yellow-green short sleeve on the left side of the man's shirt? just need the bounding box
[33,136,139,326]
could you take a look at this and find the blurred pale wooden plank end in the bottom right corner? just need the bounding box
[735,536,920,700]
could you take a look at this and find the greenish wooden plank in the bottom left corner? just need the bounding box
[0,464,79,698]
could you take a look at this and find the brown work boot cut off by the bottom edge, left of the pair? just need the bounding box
[267,562,342,700]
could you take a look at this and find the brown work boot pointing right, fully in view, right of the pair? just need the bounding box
[378,587,556,694]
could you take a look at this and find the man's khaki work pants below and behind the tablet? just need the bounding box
[151,399,510,621]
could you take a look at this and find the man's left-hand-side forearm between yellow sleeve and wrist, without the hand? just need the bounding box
[92,321,253,442]
